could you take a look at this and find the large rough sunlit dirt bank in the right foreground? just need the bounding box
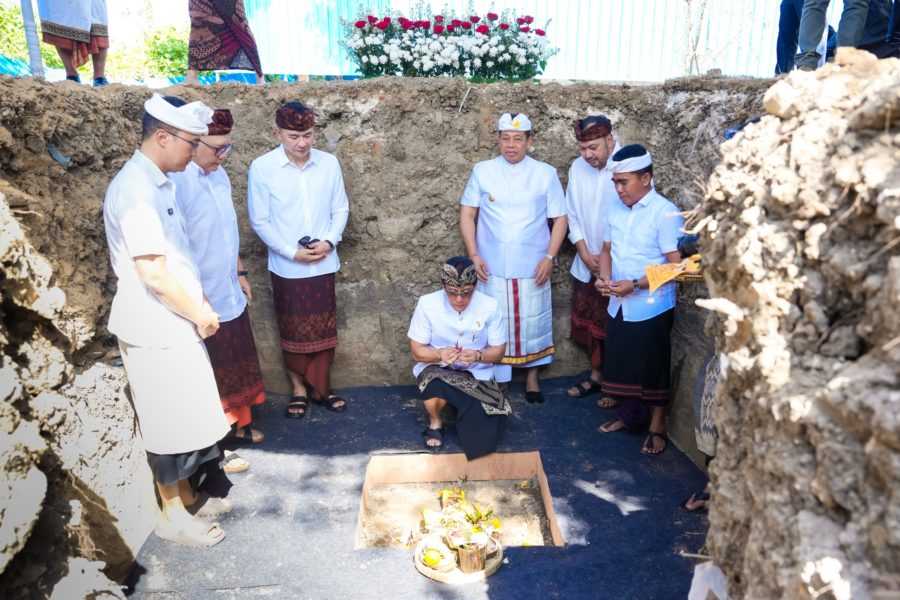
[700,50,900,600]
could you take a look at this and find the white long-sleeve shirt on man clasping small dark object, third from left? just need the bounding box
[247,146,350,279]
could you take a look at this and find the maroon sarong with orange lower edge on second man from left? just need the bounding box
[203,308,266,427]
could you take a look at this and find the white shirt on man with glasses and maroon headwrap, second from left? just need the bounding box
[169,162,247,322]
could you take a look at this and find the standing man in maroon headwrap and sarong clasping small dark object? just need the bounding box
[247,102,350,419]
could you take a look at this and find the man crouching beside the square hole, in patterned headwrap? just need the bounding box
[408,256,511,460]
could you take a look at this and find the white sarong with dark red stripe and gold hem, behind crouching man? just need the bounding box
[478,276,556,382]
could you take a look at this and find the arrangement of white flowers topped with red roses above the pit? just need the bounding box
[345,13,558,81]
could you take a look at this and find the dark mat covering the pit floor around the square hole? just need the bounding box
[131,378,706,600]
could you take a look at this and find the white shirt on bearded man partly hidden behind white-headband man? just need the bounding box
[566,156,620,283]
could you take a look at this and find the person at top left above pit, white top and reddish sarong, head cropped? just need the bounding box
[38,0,109,87]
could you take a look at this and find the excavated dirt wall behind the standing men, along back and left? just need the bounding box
[0,78,767,598]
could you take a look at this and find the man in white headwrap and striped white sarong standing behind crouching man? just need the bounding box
[459,113,567,403]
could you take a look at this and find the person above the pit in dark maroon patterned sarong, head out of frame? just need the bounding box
[185,0,265,85]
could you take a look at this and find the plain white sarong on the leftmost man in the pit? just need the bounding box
[119,340,229,454]
